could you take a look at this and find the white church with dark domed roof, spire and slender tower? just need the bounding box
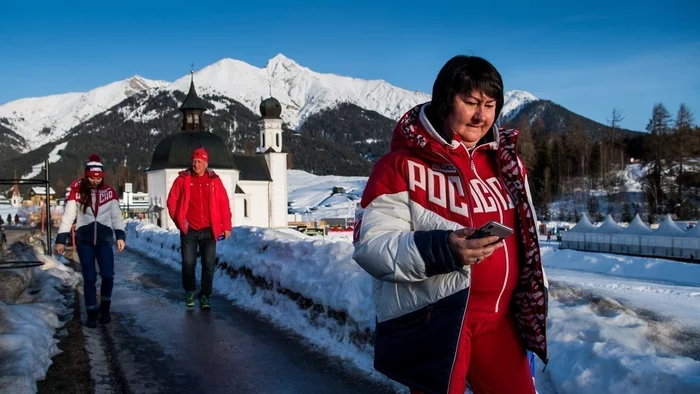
[146,73,287,229]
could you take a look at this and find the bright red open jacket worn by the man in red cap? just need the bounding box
[168,169,231,239]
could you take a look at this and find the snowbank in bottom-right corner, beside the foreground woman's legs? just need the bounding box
[538,289,700,394]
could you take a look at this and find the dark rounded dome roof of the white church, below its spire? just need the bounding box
[146,131,237,171]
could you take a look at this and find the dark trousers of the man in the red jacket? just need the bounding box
[180,227,216,297]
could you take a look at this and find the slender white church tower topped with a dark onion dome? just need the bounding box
[258,97,287,228]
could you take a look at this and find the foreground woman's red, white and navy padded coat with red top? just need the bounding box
[353,105,547,394]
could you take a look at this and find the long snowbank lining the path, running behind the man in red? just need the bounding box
[126,221,374,330]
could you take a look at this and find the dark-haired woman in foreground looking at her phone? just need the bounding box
[353,56,547,394]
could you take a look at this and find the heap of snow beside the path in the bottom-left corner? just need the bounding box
[0,243,80,394]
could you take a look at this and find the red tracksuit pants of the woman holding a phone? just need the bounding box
[411,311,535,394]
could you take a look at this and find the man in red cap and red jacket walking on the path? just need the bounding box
[168,148,231,309]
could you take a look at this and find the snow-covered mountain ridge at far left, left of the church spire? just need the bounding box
[0,75,168,151]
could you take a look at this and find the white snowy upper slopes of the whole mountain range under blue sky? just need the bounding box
[0,54,537,151]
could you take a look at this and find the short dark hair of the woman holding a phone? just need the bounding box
[431,55,504,121]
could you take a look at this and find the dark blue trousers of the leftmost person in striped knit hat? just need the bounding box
[76,243,114,309]
